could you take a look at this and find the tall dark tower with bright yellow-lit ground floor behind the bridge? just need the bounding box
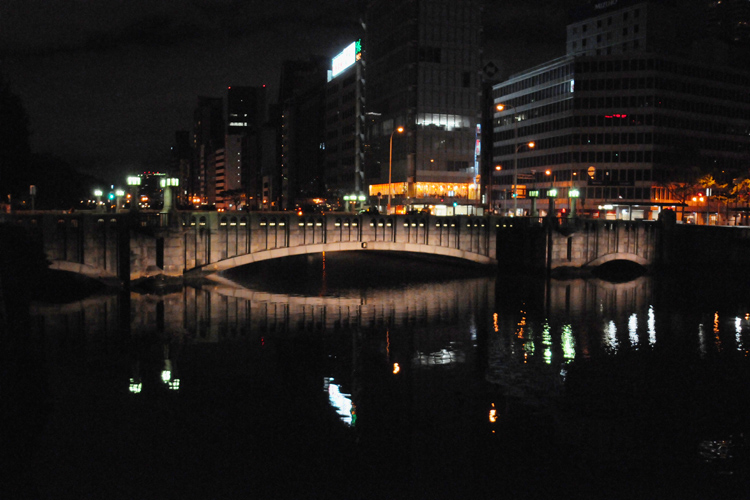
[364,0,482,213]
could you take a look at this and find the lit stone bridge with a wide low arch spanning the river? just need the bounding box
[0,211,750,282]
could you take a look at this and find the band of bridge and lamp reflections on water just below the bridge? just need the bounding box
[32,277,750,408]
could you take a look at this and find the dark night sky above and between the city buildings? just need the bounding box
[0,0,585,182]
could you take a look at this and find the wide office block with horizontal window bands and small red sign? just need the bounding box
[491,2,750,219]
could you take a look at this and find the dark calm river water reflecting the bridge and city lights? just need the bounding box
[5,253,750,499]
